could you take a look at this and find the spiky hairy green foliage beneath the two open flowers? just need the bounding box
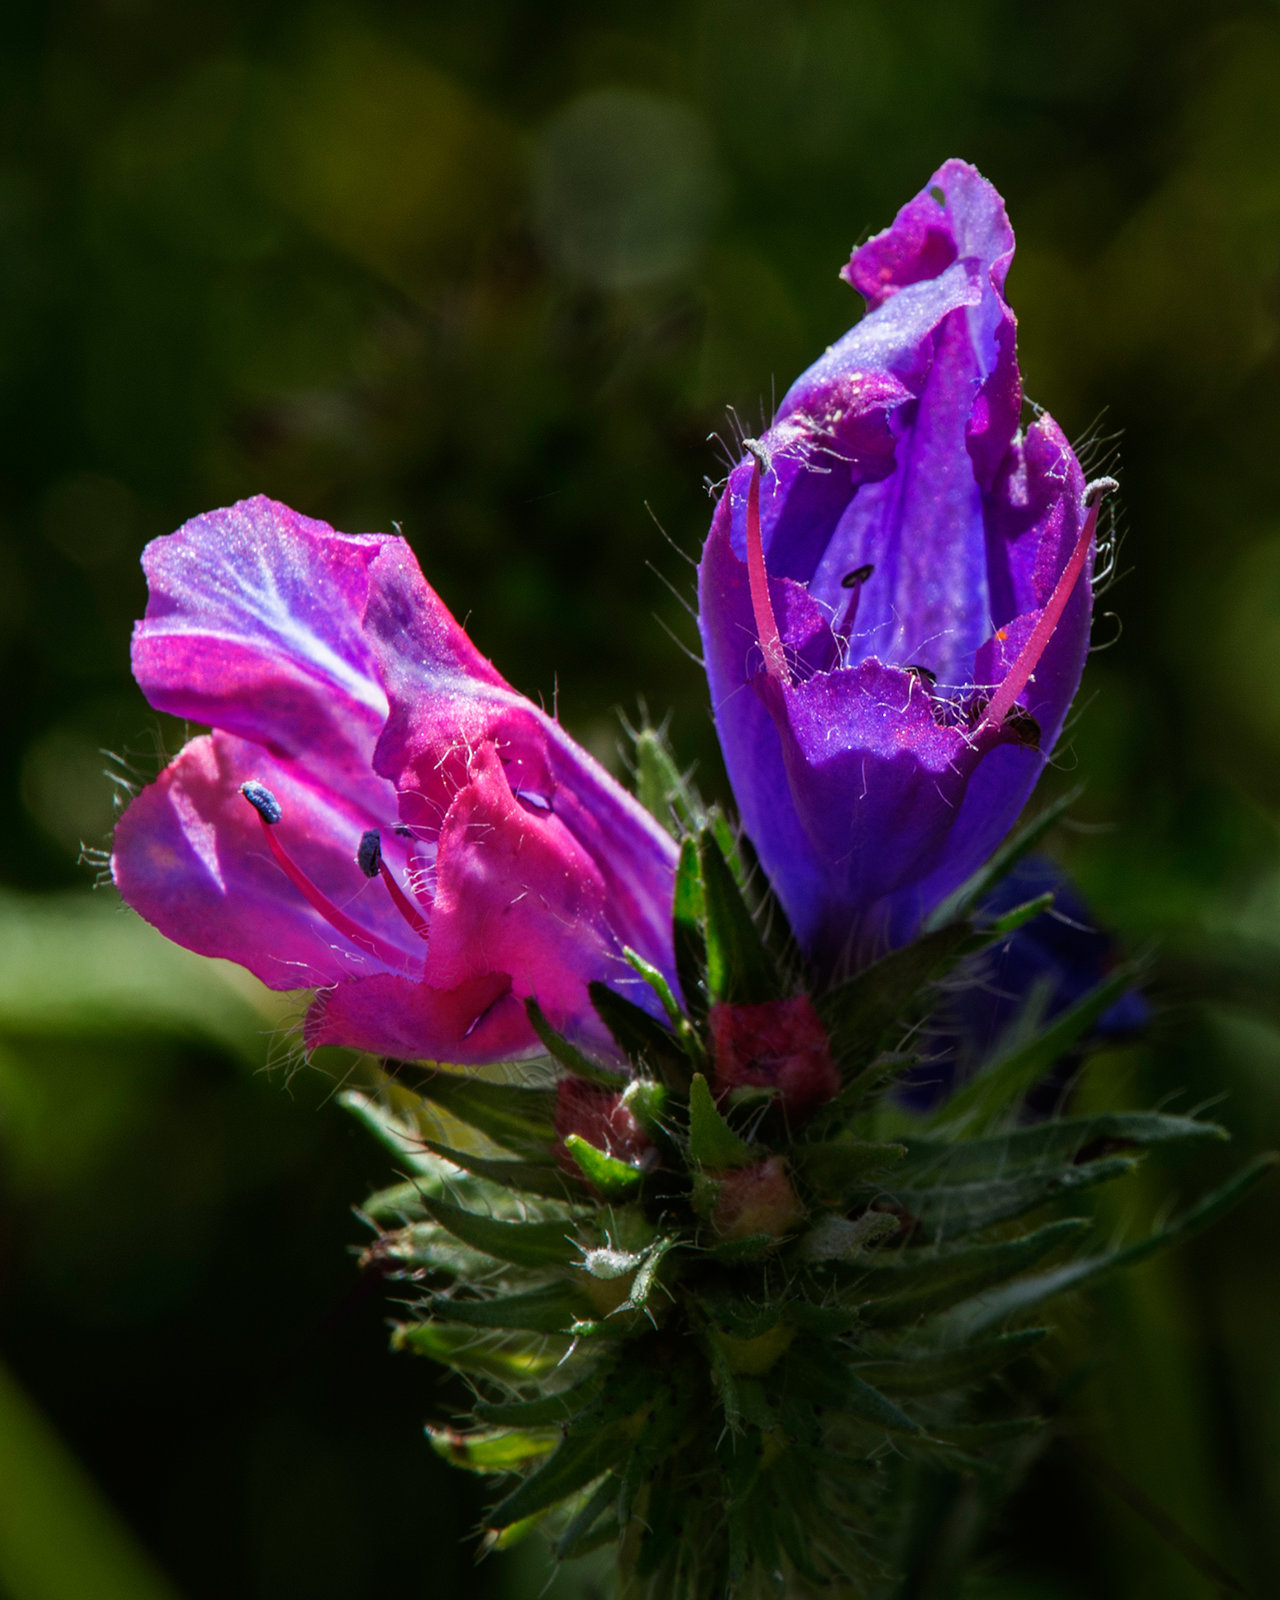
[352,734,1261,1600]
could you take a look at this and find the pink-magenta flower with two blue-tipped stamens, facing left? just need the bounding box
[112,498,675,1062]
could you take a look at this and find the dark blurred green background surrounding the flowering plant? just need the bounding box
[0,0,1280,1600]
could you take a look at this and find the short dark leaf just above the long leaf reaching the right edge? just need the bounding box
[827,1218,1088,1328]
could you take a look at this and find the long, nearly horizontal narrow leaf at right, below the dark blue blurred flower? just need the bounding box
[898,1110,1229,1184]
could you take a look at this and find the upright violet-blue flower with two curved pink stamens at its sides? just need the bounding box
[699,162,1098,978]
